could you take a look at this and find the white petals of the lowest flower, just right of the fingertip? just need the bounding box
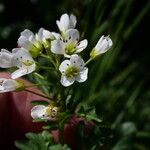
[31,105,47,119]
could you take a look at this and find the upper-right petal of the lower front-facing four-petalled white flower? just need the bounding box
[70,54,85,70]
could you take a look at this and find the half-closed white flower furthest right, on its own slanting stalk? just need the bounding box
[90,35,113,58]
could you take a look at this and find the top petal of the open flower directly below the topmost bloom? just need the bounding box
[65,29,79,43]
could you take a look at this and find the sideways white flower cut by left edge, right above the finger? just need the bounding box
[0,78,23,93]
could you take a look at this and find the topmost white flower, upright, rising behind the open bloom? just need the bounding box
[56,14,77,33]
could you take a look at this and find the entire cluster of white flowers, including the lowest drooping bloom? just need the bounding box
[0,14,112,120]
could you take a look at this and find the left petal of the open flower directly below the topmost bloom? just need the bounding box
[51,40,64,54]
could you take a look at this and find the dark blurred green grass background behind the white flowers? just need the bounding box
[0,0,150,150]
